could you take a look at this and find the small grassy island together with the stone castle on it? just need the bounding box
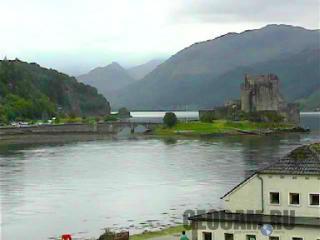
[154,74,307,136]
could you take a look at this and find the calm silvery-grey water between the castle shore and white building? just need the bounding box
[0,113,320,240]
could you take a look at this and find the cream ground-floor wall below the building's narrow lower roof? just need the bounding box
[192,222,320,240]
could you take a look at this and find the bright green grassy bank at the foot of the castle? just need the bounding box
[154,120,295,136]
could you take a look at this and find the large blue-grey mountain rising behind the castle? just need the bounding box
[112,25,320,109]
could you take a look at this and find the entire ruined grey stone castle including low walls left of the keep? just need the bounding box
[199,74,300,124]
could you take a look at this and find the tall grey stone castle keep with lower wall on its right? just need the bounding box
[241,74,300,123]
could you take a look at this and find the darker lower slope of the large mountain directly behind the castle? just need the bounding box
[114,49,320,109]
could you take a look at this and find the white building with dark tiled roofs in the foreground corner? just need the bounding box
[189,143,320,240]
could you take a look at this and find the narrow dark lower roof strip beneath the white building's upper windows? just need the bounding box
[189,210,320,227]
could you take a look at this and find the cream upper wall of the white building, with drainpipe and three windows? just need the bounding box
[224,174,320,217]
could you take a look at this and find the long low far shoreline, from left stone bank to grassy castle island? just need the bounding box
[0,121,310,143]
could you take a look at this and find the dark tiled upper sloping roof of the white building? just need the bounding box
[221,143,320,199]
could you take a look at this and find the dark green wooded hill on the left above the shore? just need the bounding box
[0,59,110,121]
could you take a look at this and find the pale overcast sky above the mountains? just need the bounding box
[0,0,320,74]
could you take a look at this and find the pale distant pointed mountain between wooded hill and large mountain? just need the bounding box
[77,62,135,97]
